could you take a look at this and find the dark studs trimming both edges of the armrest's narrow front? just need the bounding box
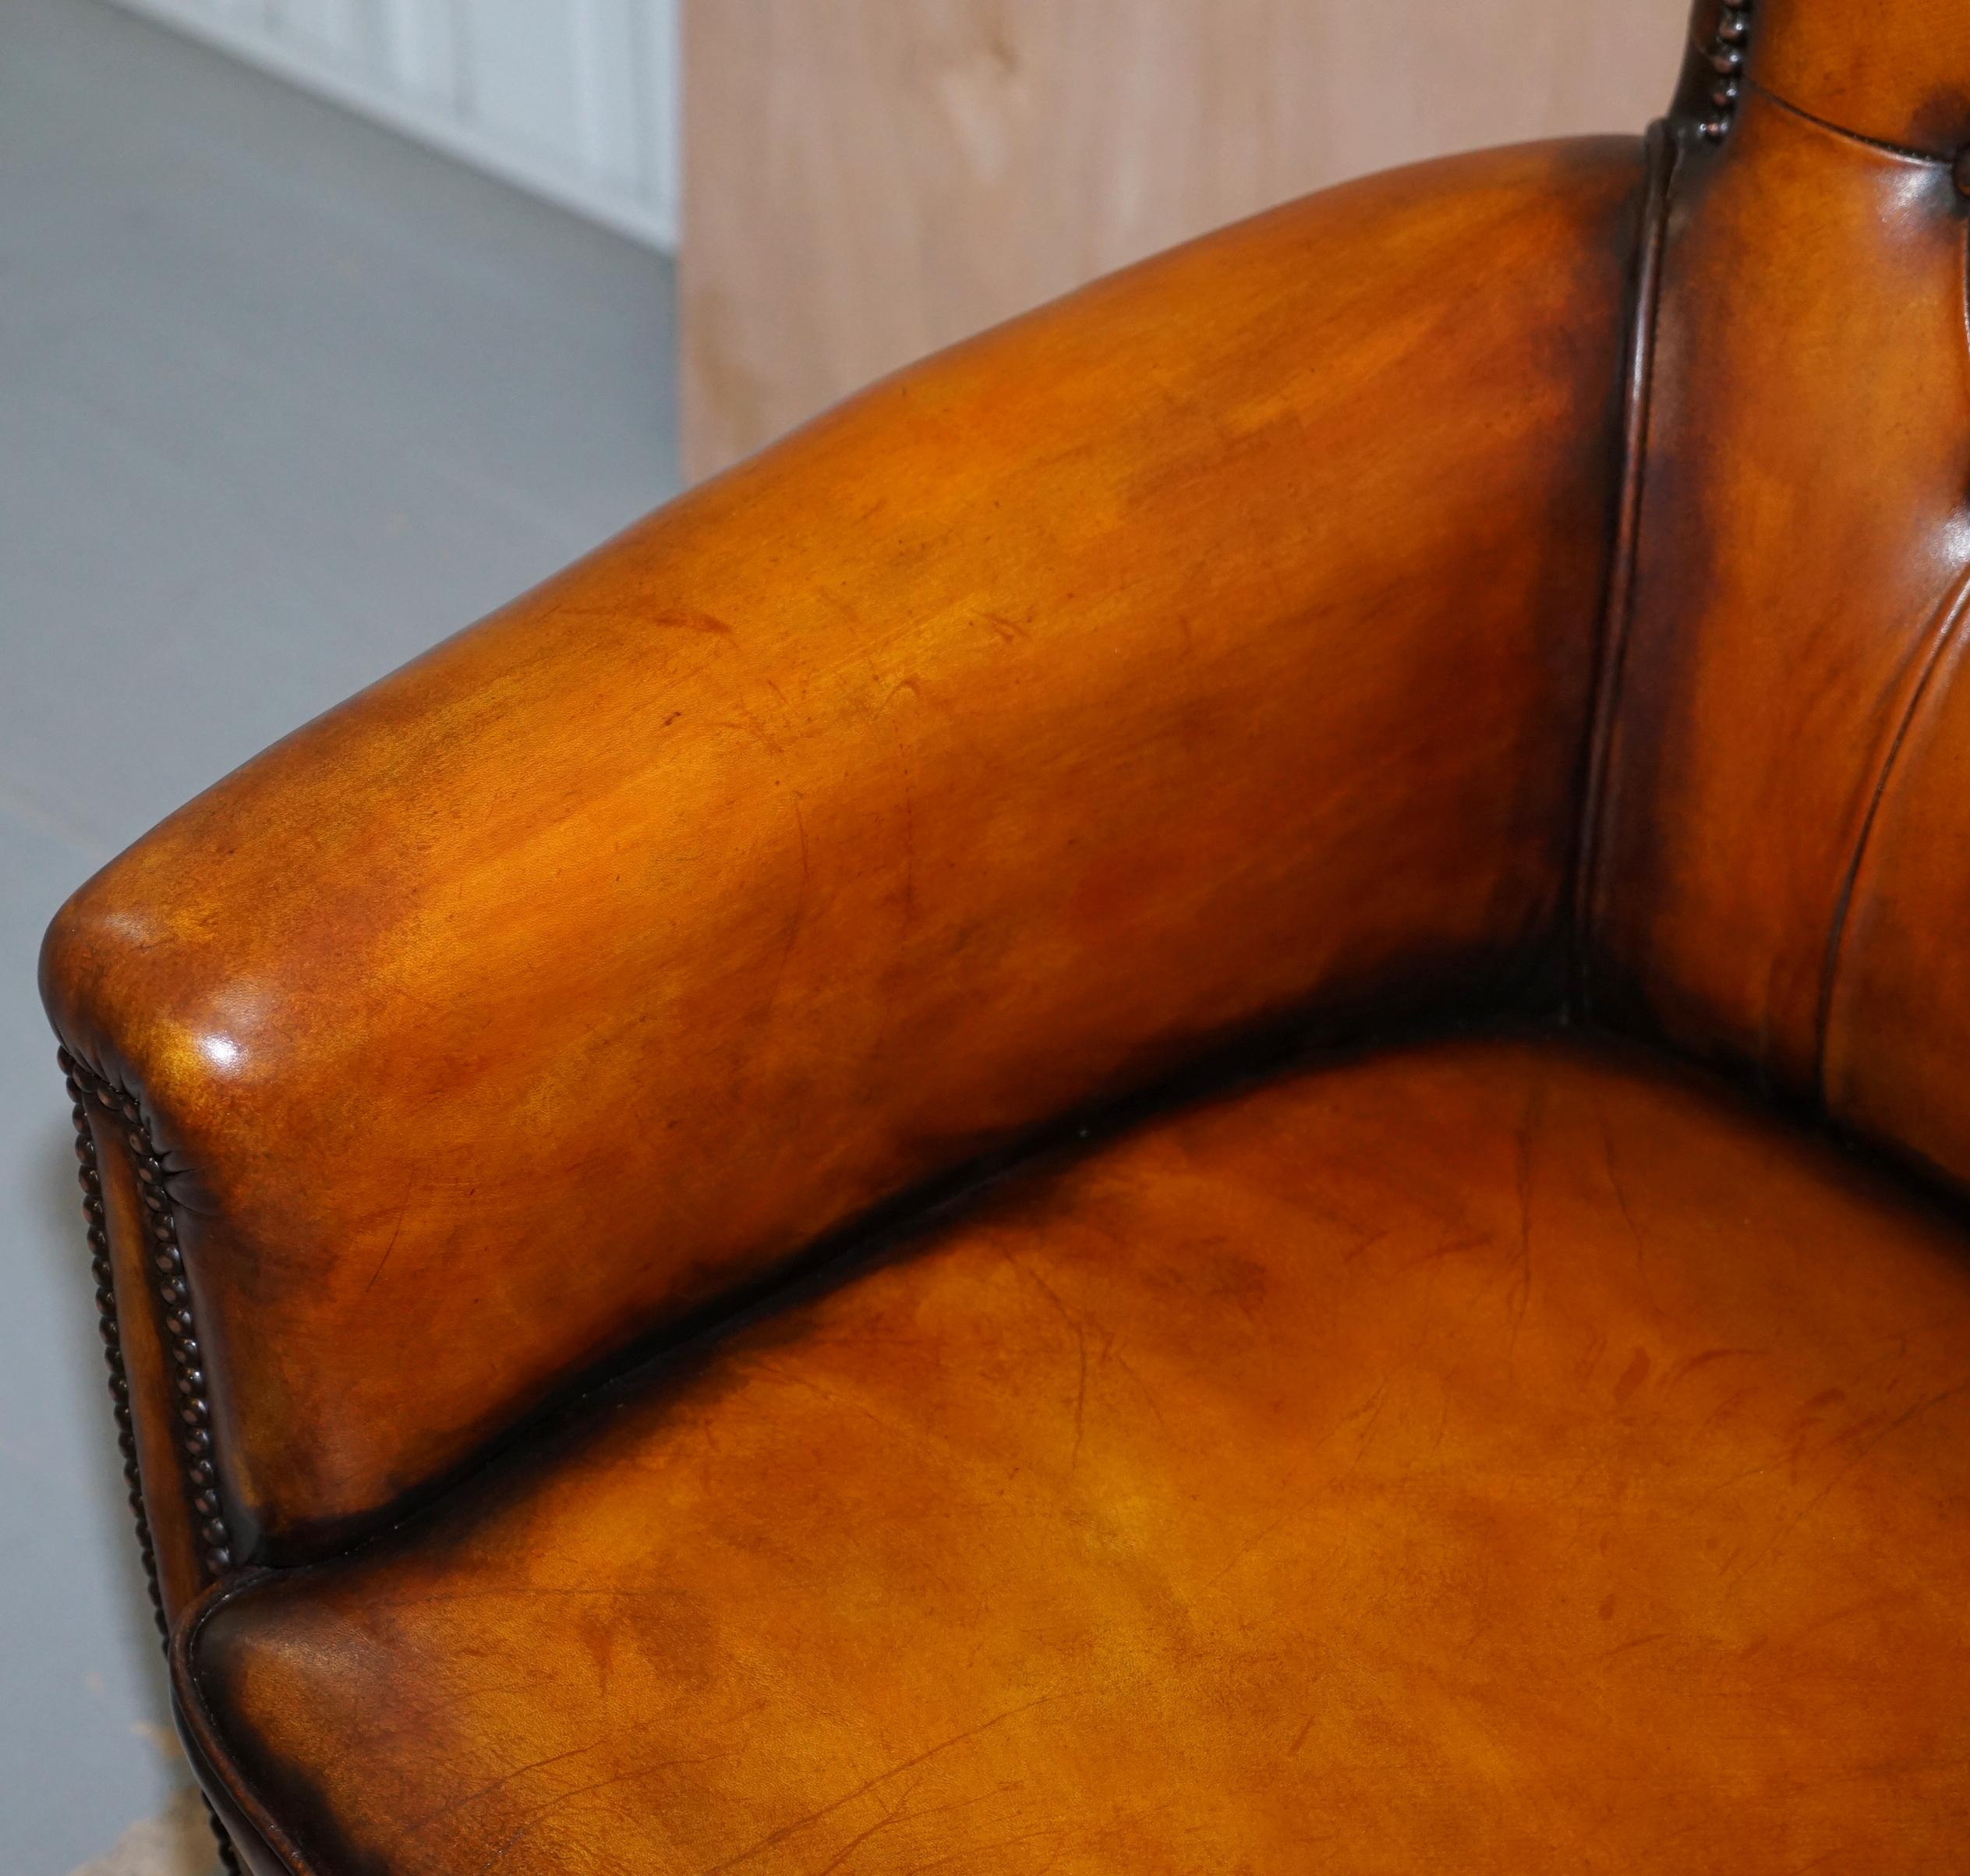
[59,1049,232,1576]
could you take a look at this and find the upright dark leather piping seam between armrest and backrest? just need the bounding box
[1572,120,1681,1015]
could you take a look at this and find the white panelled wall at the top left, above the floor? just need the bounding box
[109,0,680,248]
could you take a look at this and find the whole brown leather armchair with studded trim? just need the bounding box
[45,0,1970,1876]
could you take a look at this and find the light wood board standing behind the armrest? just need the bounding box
[681,0,1686,475]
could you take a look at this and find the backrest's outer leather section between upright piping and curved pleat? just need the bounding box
[1590,89,1964,1103]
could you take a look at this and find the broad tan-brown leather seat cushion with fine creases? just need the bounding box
[187,1039,1970,1876]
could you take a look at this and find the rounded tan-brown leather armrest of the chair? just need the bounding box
[44,140,1641,1600]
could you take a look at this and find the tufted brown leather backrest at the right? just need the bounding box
[1584,0,1970,1178]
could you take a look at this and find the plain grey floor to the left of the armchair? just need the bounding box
[0,0,676,1876]
